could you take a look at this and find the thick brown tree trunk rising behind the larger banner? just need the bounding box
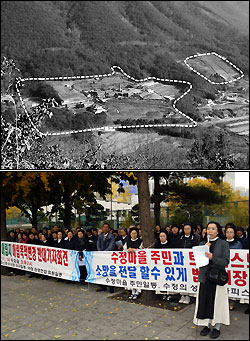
[137,172,155,305]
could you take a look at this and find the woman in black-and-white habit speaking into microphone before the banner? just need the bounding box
[193,222,230,339]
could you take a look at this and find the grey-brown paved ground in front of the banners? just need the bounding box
[1,276,249,340]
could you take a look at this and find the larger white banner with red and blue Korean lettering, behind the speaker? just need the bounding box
[83,249,249,299]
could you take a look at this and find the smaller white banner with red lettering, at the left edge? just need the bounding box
[1,241,80,281]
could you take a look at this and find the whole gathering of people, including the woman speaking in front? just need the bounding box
[8,222,249,339]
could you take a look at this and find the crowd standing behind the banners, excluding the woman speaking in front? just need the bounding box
[8,223,249,302]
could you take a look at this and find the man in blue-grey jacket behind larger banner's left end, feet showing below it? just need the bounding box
[96,223,115,293]
